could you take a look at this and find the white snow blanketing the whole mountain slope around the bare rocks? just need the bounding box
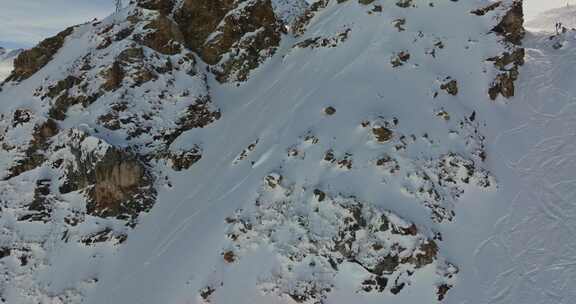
[0,0,576,304]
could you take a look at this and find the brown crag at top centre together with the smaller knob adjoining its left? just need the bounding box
[132,0,284,82]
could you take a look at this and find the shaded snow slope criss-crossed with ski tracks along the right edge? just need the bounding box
[475,31,576,304]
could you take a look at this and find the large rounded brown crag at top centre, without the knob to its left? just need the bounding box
[174,0,282,82]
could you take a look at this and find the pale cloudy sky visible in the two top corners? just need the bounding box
[0,0,576,48]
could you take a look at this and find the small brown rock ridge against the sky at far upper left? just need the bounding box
[6,27,74,81]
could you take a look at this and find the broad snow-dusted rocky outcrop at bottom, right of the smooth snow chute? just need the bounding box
[220,173,458,303]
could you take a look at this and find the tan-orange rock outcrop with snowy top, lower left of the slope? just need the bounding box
[59,130,155,224]
